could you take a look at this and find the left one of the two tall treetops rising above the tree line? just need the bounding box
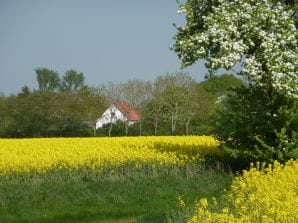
[35,68,60,91]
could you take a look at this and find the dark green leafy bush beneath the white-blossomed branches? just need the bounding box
[217,86,298,164]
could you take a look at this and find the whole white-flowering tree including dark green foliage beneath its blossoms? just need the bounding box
[172,0,298,164]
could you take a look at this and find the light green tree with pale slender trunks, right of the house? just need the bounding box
[147,72,198,135]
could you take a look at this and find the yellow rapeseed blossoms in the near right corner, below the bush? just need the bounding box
[188,160,298,223]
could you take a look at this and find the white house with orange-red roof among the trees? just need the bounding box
[96,103,140,129]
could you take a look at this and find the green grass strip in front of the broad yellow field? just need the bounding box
[0,164,230,223]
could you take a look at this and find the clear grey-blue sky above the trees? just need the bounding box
[0,0,210,95]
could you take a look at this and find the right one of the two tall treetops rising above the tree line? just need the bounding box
[61,69,85,91]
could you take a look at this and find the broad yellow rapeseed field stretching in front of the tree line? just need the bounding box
[0,136,218,175]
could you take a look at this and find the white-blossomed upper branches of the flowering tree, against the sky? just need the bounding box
[173,0,298,98]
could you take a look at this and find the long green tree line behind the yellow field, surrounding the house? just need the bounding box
[0,68,244,138]
